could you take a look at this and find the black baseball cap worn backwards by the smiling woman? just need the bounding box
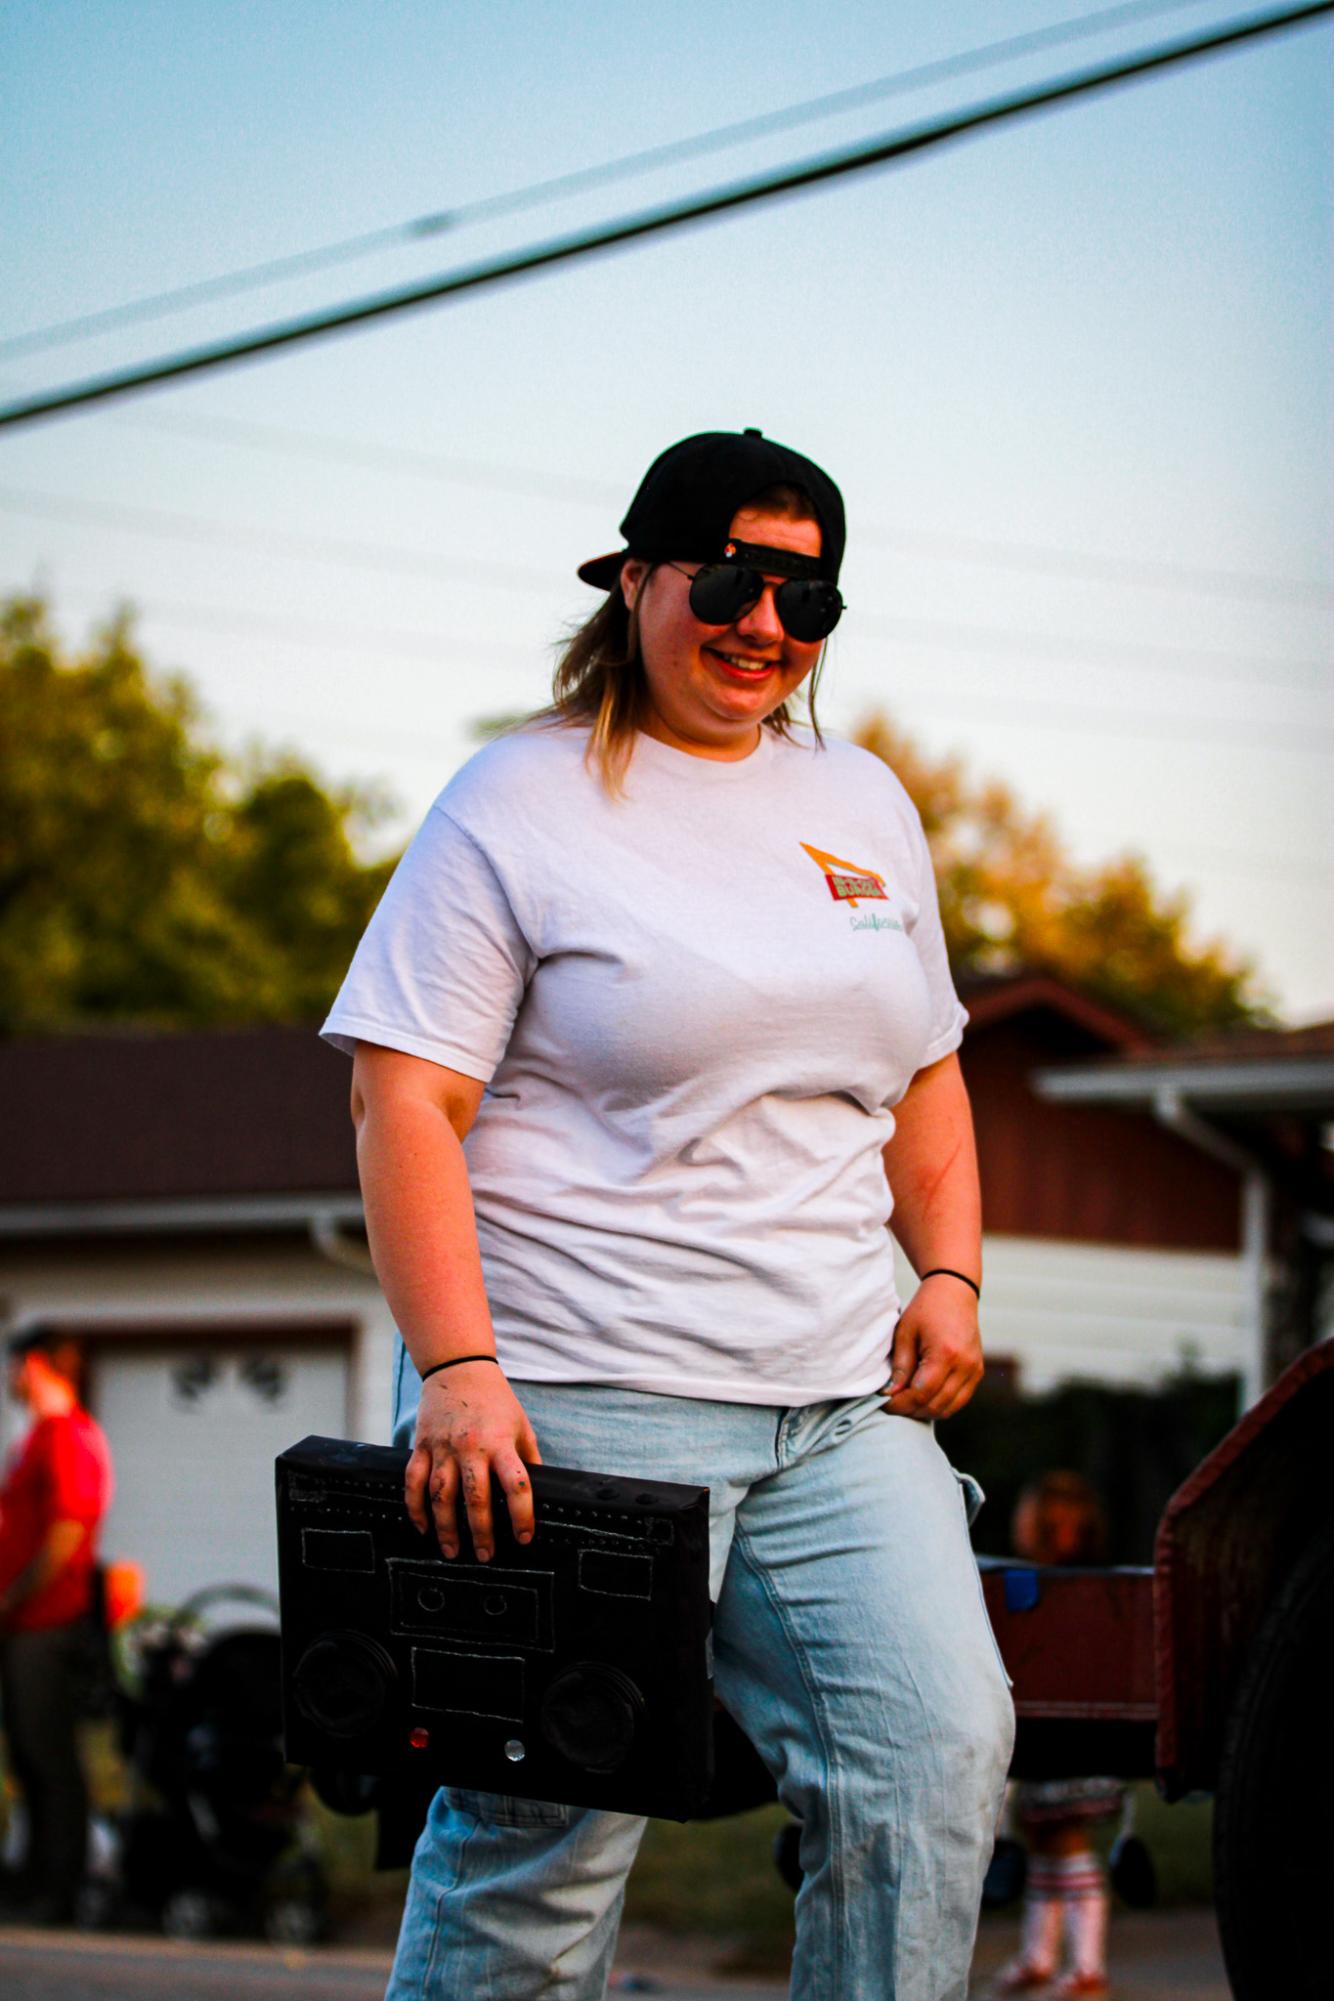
[578,430,848,590]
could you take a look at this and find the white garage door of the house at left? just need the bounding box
[92,1345,348,1605]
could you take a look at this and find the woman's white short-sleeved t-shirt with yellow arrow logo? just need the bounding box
[324,724,966,1405]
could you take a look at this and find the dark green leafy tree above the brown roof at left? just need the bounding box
[0,598,392,1035]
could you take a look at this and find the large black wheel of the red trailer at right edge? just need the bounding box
[1214,1539,1334,2001]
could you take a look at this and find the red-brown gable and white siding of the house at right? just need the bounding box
[962,976,1246,1393]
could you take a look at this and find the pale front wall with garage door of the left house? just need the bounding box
[0,1239,404,1603]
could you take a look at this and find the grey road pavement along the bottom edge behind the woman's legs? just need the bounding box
[0,1911,1230,2001]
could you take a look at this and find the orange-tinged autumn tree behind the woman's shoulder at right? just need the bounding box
[856,714,1272,1037]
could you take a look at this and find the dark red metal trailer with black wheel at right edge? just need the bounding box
[982,1341,1334,2001]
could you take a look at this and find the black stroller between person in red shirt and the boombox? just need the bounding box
[96,1585,328,1945]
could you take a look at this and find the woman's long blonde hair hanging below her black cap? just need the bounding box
[534,486,824,796]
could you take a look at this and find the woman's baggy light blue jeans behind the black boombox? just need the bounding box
[386,1369,1014,2001]
